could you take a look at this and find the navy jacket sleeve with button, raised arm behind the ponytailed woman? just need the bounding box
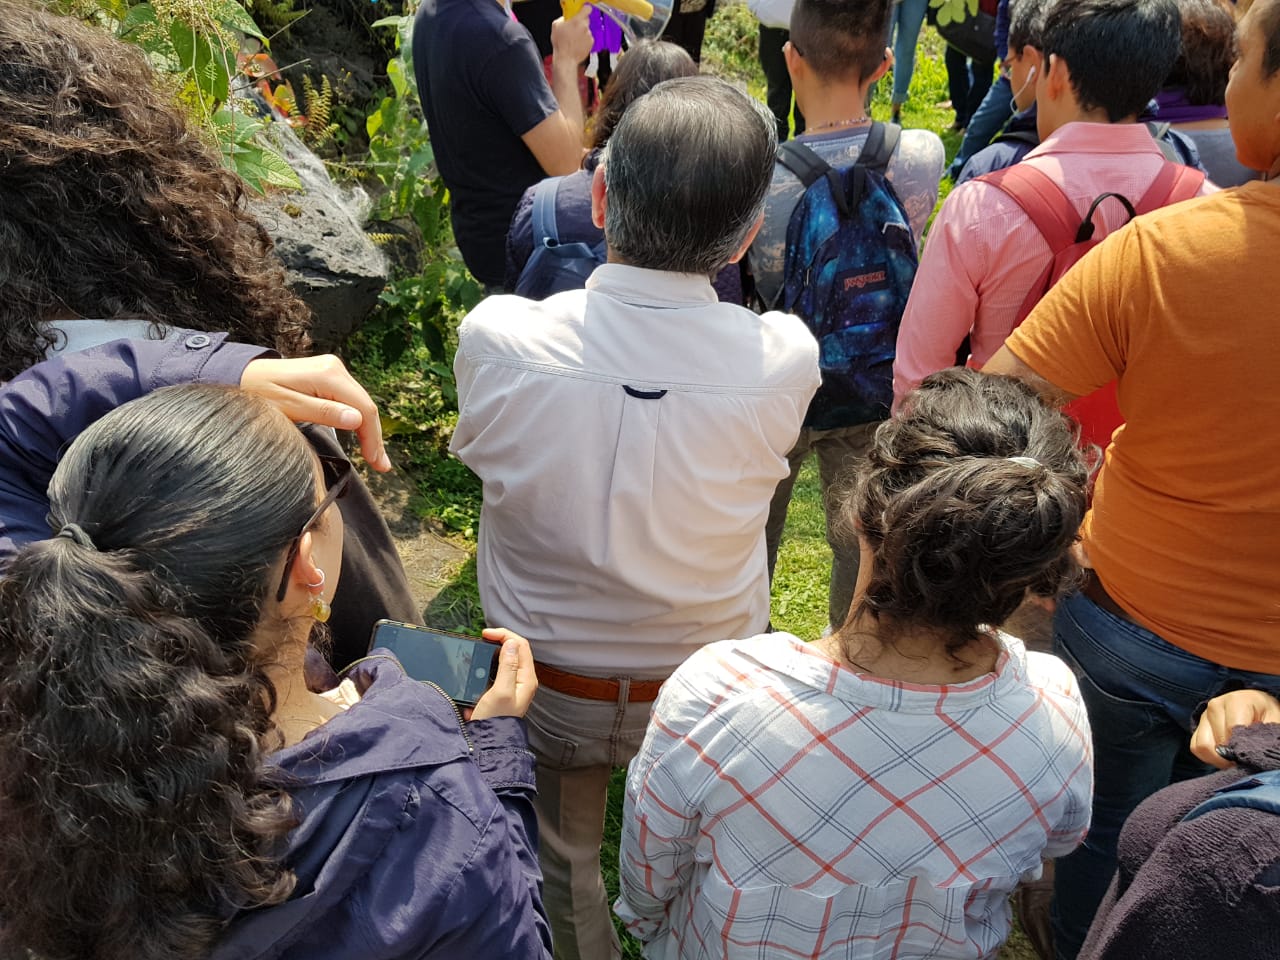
[0,330,263,570]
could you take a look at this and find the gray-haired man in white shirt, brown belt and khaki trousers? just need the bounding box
[452,77,819,960]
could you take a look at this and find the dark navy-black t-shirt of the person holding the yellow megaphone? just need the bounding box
[413,0,559,284]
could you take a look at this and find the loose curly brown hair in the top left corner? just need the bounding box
[0,0,310,380]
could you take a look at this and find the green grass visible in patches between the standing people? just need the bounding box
[348,11,1034,960]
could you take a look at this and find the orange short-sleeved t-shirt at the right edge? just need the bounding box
[1007,182,1280,673]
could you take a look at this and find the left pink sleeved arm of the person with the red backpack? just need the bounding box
[893,184,986,411]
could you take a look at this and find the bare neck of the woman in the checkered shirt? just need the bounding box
[818,616,1000,686]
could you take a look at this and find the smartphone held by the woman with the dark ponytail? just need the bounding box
[370,620,502,707]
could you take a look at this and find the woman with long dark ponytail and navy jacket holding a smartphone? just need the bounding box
[0,387,550,960]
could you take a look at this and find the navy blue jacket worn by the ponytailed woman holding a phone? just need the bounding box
[210,650,552,960]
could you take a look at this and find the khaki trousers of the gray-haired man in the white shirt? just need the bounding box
[525,678,653,960]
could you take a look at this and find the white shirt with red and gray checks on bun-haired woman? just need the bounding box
[614,634,1092,960]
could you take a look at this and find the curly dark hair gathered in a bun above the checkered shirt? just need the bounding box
[847,369,1088,654]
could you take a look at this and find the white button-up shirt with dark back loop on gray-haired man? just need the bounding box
[452,264,819,677]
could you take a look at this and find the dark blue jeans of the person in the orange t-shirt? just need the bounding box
[1052,594,1280,960]
